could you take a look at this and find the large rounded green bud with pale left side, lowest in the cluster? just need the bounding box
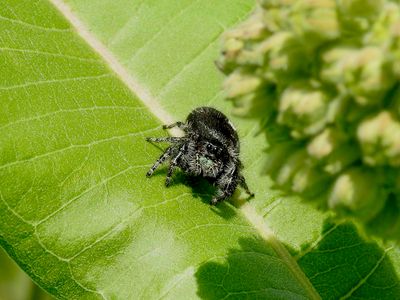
[328,168,386,220]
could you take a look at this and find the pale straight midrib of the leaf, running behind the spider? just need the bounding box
[49,0,321,299]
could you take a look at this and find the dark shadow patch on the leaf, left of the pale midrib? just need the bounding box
[195,238,307,300]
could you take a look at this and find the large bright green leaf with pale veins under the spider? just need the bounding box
[0,0,400,299]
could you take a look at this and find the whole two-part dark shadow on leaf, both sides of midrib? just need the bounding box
[196,220,400,300]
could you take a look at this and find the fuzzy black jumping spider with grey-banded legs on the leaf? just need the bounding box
[146,107,254,205]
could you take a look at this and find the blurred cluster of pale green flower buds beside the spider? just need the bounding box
[218,0,400,239]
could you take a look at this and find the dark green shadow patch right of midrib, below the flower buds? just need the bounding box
[296,220,400,299]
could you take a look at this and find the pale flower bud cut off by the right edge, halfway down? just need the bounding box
[357,111,400,167]
